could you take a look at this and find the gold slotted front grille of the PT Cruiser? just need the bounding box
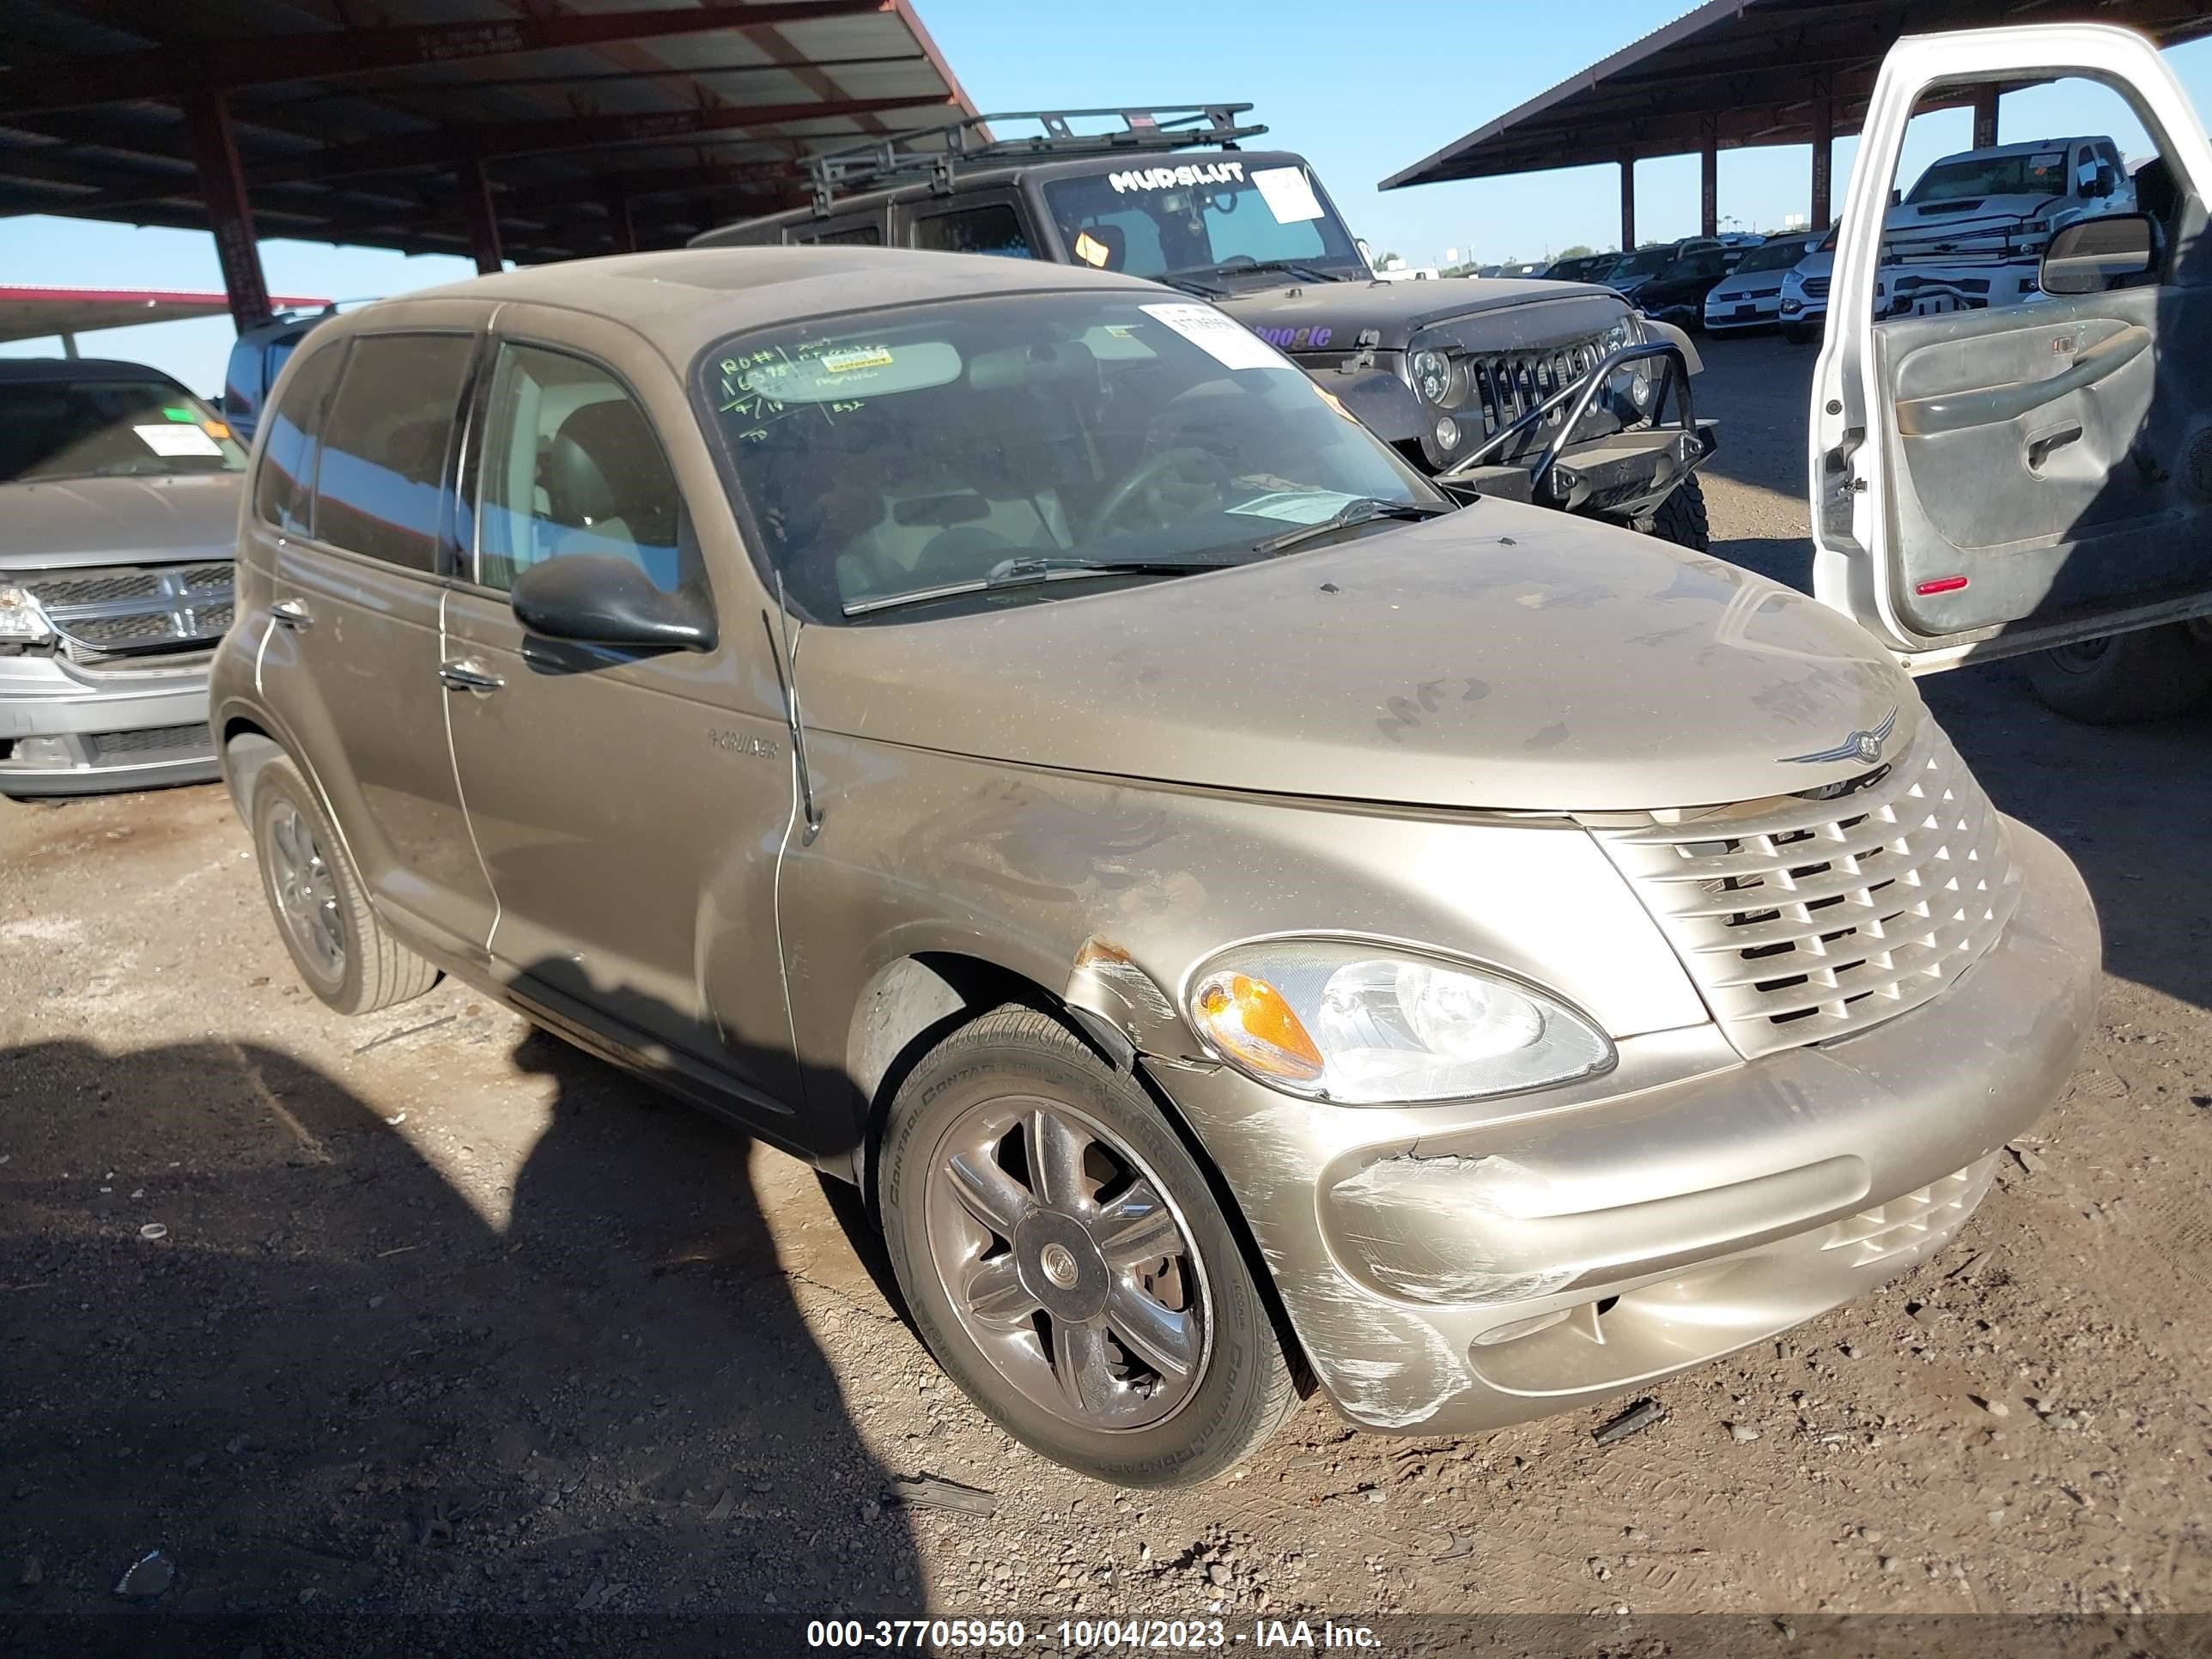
[1590,719,2020,1060]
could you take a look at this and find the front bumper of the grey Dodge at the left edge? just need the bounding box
[0,654,216,796]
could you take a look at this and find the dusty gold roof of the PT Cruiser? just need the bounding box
[336,246,1182,362]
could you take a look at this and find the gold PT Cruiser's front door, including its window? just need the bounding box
[442,307,796,1133]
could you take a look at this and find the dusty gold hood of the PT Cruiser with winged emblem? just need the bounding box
[799,500,1920,811]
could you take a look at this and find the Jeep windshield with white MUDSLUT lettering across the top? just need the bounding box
[1044,159,1367,281]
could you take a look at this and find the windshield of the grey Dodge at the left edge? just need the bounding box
[0,378,246,484]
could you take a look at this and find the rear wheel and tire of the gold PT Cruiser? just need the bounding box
[250,754,438,1013]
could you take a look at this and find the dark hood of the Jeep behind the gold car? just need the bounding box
[1212,272,1626,352]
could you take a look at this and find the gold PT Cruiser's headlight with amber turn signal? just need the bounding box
[1188,940,1613,1106]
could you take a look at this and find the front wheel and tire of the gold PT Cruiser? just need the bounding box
[876,1005,1298,1486]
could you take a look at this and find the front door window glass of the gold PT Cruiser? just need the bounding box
[476,345,686,592]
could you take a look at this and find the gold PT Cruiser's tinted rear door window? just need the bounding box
[313,334,476,571]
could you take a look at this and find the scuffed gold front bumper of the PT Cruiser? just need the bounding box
[1155,823,2100,1431]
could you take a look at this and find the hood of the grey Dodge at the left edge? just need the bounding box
[0,473,243,571]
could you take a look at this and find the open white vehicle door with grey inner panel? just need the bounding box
[1809,24,2212,672]
